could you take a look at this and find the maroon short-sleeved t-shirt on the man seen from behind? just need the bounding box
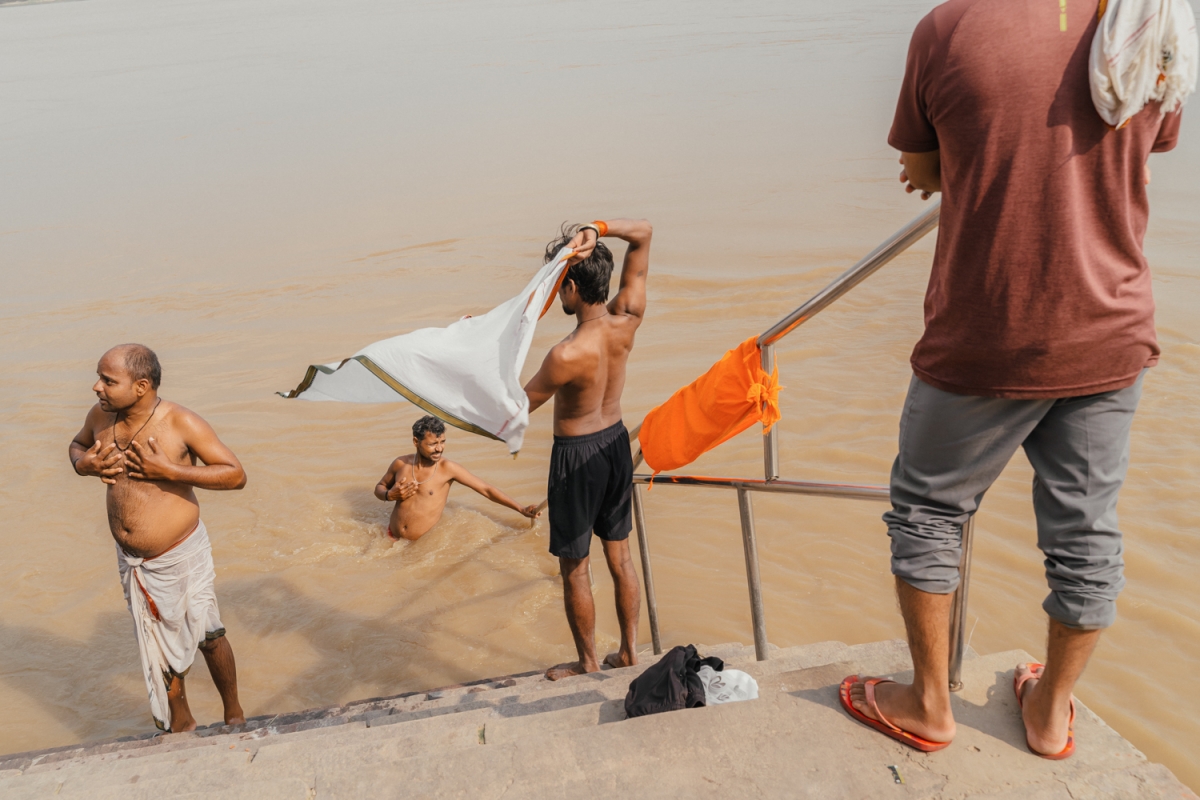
[888,0,1180,398]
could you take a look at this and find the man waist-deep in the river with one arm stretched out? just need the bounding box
[374,416,541,541]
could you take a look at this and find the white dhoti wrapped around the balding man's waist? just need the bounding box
[116,522,224,730]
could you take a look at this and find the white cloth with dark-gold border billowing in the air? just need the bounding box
[280,247,571,453]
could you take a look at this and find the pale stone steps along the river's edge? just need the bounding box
[0,642,1196,800]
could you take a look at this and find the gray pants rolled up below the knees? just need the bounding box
[883,371,1146,628]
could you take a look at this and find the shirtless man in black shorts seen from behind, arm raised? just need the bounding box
[526,219,653,680]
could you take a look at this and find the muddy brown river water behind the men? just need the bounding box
[0,0,1200,788]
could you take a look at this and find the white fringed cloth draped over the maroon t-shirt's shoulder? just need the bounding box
[1087,0,1200,128]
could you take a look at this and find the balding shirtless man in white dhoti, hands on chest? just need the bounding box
[70,344,246,732]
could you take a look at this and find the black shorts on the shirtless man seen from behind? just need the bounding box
[546,422,634,559]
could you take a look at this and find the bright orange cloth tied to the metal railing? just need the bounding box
[637,337,780,473]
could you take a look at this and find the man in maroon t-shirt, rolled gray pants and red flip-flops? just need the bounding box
[841,0,1180,758]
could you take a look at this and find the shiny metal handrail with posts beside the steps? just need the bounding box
[539,203,974,691]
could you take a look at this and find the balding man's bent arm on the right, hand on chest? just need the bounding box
[127,409,246,491]
